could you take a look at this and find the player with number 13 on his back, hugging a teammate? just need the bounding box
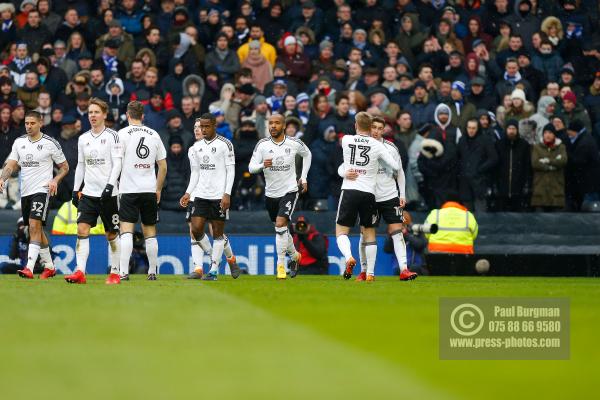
[335,112,400,281]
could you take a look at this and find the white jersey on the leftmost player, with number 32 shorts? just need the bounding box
[8,134,66,197]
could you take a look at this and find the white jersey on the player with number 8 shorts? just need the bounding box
[77,128,122,197]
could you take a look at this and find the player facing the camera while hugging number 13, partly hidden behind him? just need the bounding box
[345,116,417,281]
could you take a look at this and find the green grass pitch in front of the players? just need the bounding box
[0,275,600,400]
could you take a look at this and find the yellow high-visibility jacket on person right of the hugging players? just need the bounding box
[425,201,479,254]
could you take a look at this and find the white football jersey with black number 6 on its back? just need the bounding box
[118,125,167,193]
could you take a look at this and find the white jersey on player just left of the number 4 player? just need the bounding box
[188,135,235,200]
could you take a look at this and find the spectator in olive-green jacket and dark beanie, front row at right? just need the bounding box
[531,124,567,211]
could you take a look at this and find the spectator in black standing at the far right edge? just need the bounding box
[565,120,600,211]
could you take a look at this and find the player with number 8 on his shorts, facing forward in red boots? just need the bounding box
[65,98,123,284]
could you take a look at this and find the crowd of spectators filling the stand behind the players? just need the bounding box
[0,0,600,216]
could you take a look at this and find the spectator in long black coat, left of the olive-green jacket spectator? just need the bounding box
[495,119,531,212]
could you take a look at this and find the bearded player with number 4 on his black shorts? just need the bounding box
[248,114,312,279]
